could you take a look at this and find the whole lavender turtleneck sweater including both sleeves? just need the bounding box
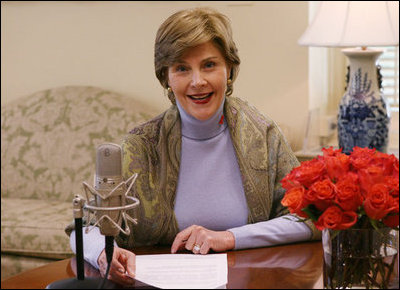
[70,101,312,269]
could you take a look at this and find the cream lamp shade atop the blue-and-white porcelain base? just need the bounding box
[298,1,399,47]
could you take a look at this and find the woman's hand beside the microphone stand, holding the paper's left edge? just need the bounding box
[97,247,136,285]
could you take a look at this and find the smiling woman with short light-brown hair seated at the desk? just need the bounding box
[67,8,319,284]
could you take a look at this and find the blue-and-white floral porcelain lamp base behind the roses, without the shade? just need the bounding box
[338,49,390,154]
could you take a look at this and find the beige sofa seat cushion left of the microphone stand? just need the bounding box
[1,198,73,259]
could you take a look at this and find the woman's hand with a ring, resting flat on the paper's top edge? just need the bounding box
[171,225,235,255]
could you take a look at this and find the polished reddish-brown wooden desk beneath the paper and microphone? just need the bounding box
[1,242,323,289]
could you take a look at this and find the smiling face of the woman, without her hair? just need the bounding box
[168,41,229,120]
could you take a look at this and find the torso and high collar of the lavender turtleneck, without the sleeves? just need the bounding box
[174,101,248,231]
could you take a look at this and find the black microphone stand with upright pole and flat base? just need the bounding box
[46,195,119,289]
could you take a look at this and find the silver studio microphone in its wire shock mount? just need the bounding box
[83,143,139,237]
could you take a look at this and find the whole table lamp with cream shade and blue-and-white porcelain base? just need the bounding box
[298,1,399,154]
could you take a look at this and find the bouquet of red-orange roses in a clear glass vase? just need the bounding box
[281,147,399,288]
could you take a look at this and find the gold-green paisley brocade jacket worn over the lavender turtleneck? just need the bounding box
[116,97,320,249]
